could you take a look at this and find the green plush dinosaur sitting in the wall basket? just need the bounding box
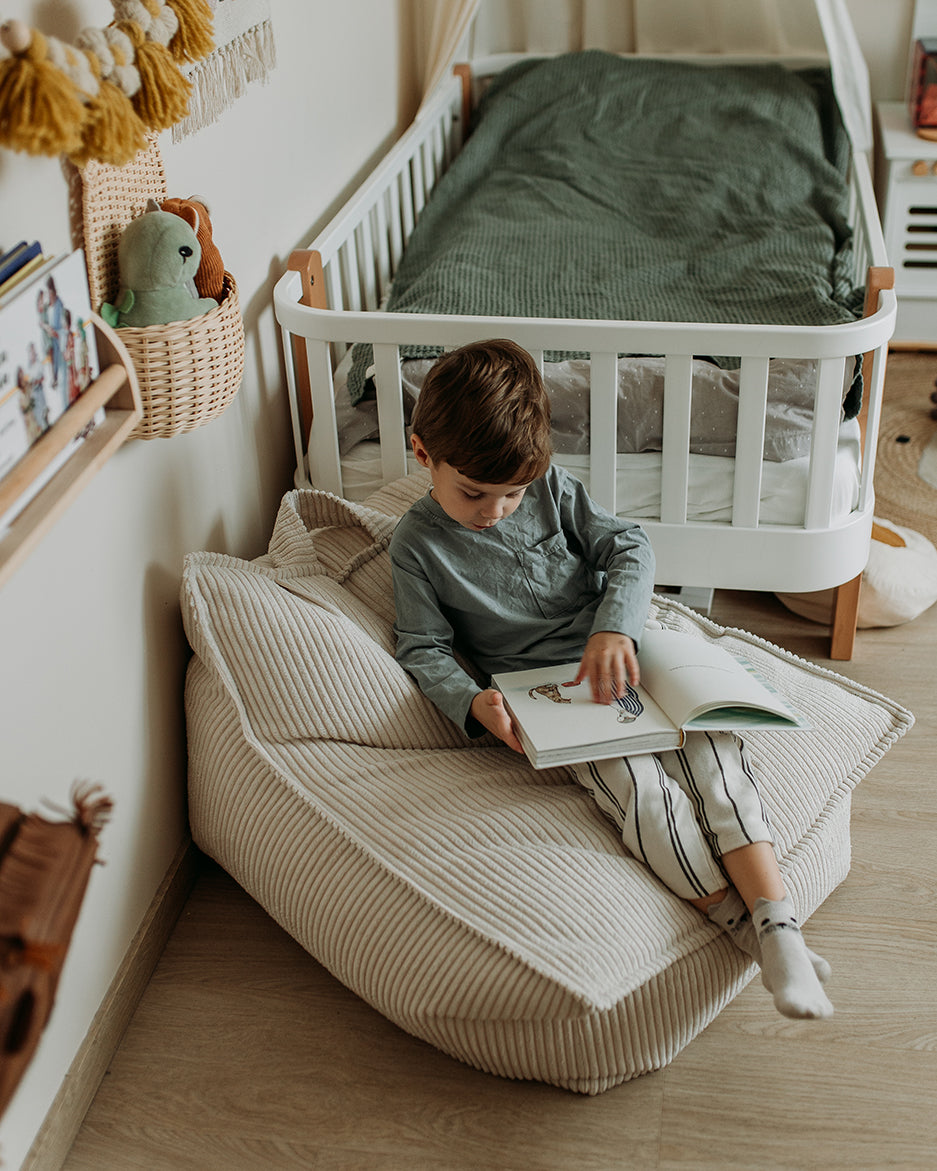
[101,200,218,328]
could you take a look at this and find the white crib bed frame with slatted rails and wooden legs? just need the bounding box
[274,22,896,658]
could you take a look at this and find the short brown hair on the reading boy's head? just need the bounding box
[412,338,552,484]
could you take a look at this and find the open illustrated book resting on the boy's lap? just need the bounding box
[491,629,811,768]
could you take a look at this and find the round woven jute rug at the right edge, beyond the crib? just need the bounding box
[875,350,937,545]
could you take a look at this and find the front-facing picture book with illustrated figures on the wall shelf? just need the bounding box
[0,249,100,477]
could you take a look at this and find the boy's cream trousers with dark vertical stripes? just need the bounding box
[573,732,774,899]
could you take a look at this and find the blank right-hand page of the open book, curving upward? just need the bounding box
[638,630,806,728]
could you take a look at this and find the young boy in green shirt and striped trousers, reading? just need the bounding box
[390,341,833,1018]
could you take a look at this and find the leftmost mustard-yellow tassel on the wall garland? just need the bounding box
[0,20,84,155]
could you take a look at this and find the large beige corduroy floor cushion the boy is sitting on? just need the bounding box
[182,475,911,1094]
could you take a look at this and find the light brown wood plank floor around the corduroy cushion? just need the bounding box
[66,594,937,1171]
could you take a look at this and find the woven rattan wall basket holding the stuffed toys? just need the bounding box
[70,137,244,439]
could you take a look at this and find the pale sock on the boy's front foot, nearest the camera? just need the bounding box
[752,898,833,1018]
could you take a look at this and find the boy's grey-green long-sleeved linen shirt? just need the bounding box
[390,465,654,735]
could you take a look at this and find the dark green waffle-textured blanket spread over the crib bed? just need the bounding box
[349,50,862,413]
